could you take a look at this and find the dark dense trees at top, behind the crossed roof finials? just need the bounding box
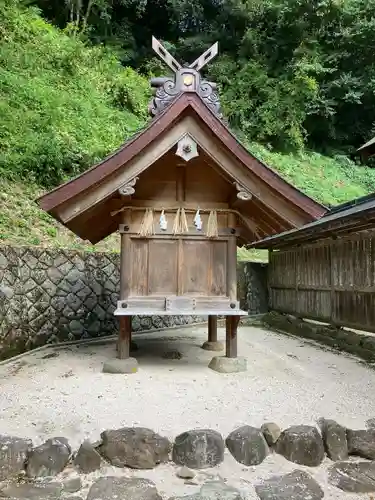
[29,0,375,153]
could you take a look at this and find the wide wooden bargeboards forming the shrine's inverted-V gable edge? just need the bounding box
[38,94,325,245]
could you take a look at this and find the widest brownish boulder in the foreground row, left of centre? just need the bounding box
[99,427,171,469]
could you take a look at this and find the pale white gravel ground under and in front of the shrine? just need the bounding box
[0,327,375,500]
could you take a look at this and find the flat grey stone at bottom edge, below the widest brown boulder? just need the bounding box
[87,476,162,500]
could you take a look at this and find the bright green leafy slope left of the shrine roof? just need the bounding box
[0,2,148,186]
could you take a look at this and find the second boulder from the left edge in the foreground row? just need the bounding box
[26,437,72,477]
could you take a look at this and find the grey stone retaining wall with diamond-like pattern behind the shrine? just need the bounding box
[0,246,267,360]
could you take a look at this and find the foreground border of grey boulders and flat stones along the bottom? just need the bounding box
[0,418,375,500]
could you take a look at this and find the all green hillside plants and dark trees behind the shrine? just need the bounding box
[0,0,375,254]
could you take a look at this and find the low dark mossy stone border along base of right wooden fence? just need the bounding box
[256,311,375,362]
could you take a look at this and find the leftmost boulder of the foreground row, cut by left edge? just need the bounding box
[0,435,32,481]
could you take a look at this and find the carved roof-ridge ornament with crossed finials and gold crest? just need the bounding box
[149,37,221,118]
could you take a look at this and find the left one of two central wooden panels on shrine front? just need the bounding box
[148,238,178,295]
